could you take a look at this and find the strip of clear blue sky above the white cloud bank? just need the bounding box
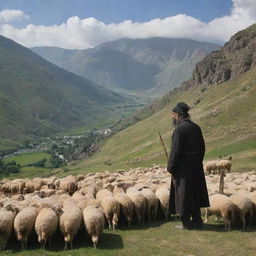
[0,0,232,25]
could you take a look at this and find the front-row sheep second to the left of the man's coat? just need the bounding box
[141,188,158,221]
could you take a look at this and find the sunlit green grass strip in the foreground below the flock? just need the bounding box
[0,218,256,256]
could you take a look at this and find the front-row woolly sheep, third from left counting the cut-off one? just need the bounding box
[35,207,58,249]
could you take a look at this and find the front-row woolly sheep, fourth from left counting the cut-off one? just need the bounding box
[59,202,83,250]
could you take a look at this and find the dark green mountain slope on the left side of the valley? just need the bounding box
[0,36,127,148]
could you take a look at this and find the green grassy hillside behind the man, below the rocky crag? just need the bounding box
[63,68,256,174]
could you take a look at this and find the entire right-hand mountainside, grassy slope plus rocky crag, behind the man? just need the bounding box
[65,24,256,173]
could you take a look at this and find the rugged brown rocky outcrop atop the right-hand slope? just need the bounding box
[191,24,256,86]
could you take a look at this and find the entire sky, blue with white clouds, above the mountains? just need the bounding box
[0,0,256,49]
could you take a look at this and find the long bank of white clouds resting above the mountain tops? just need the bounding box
[0,0,256,49]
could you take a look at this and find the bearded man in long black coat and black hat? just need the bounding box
[167,102,209,229]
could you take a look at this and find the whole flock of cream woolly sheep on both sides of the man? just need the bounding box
[0,162,256,250]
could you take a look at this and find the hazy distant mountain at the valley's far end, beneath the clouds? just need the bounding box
[32,38,219,98]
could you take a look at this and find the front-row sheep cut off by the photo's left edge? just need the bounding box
[0,207,15,250]
